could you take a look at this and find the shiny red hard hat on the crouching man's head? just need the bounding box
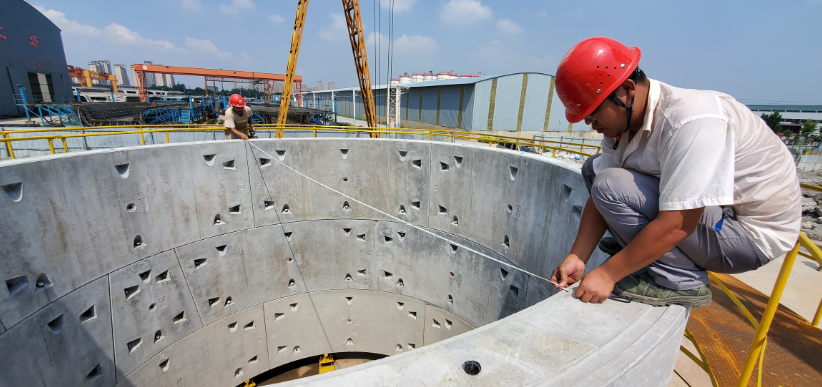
[555,36,642,122]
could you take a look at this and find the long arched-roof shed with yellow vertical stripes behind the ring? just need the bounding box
[303,72,590,132]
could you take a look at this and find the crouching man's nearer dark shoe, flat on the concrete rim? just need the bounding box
[614,272,711,308]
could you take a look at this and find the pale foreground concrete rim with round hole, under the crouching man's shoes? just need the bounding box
[272,293,686,386]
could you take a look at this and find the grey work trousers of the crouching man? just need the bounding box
[582,154,770,290]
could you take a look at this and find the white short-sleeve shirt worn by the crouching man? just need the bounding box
[594,80,802,259]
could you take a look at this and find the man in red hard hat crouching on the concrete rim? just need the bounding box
[552,37,802,307]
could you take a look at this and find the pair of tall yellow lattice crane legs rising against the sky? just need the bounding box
[277,0,377,138]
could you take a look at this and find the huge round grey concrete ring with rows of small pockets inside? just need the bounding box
[0,139,687,386]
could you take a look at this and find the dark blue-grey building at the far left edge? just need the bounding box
[0,0,71,116]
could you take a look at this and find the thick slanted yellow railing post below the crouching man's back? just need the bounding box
[736,241,803,387]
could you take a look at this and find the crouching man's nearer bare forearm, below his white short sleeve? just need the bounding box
[602,208,702,281]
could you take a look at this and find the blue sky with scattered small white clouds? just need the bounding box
[30,0,822,104]
